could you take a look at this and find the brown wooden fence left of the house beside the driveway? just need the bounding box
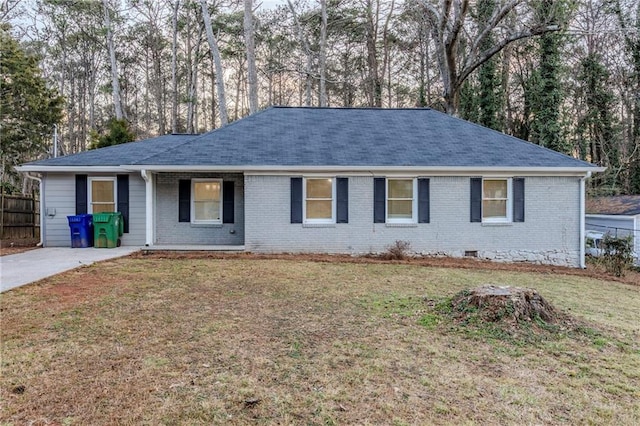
[0,192,40,240]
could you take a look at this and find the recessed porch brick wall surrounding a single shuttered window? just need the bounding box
[155,173,244,245]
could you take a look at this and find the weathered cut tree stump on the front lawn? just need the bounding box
[452,285,563,326]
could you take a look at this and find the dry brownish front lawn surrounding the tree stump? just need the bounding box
[0,256,640,425]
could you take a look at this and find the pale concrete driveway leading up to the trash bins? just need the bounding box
[0,247,140,293]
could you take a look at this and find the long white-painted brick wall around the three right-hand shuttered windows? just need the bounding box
[245,176,580,266]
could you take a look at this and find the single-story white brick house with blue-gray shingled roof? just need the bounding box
[19,107,603,267]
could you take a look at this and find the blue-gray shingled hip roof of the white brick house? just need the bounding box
[22,107,595,169]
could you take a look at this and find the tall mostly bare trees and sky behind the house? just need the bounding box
[0,0,640,195]
